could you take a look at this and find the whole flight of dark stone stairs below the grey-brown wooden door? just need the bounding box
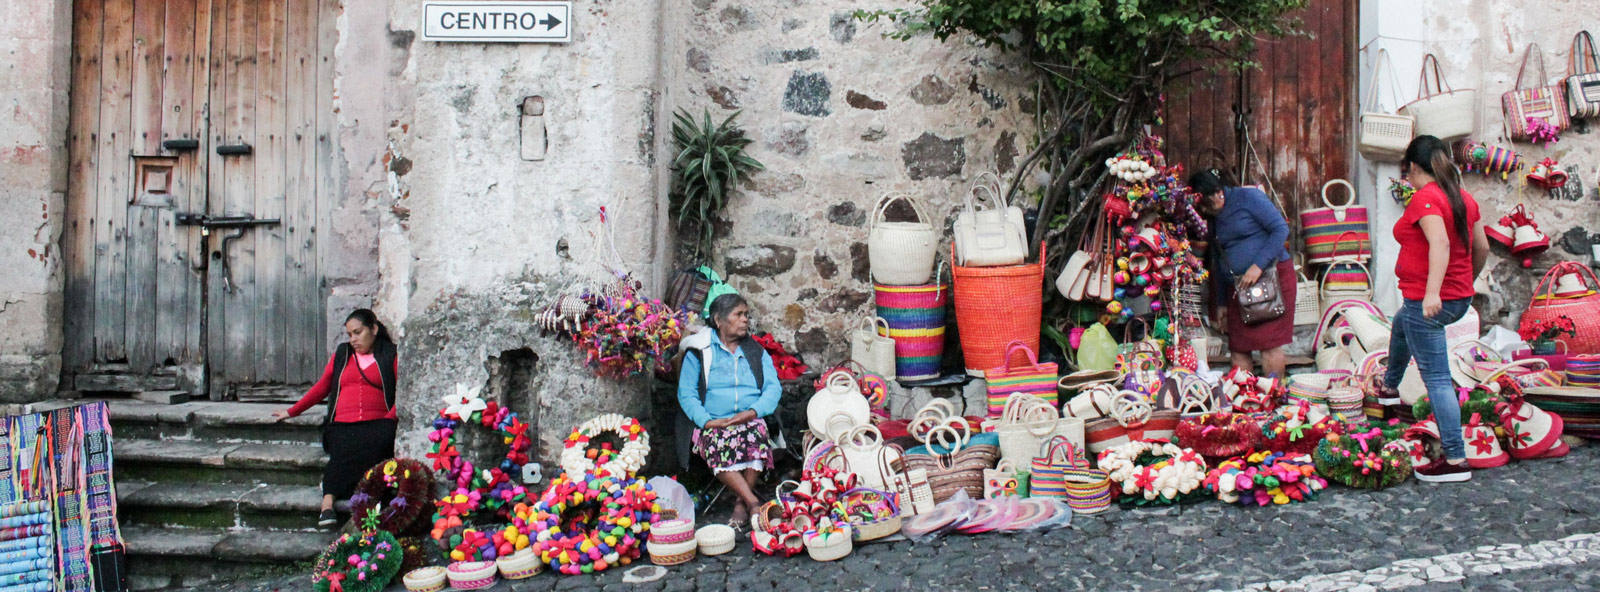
[89,398,347,590]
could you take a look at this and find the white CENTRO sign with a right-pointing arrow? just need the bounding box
[422,2,573,43]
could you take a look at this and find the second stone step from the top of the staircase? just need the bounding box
[114,438,328,485]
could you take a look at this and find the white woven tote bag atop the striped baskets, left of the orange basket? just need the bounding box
[867,194,939,286]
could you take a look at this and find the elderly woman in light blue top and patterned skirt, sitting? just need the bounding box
[678,294,782,525]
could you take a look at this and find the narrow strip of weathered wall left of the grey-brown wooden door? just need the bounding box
[0,0,72,403]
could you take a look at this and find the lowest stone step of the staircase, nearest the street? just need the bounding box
[122,525,334,590]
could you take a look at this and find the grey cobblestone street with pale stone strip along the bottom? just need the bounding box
[195,446,1600,592]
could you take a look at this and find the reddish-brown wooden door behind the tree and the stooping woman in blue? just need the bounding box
[1163,0,1357,224]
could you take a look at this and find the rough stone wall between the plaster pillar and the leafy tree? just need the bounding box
[661,0,1035,366]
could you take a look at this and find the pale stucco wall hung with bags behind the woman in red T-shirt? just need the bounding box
[1357,0,1600,328]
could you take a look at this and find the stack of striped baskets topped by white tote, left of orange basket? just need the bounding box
[867,194,950,381]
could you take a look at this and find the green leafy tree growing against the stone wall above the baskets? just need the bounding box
[854,0,1307,248]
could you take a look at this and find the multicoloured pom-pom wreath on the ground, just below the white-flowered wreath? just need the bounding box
[517,472,661,574]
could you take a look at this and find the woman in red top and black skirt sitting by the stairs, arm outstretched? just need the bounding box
[272,309,400,528]
